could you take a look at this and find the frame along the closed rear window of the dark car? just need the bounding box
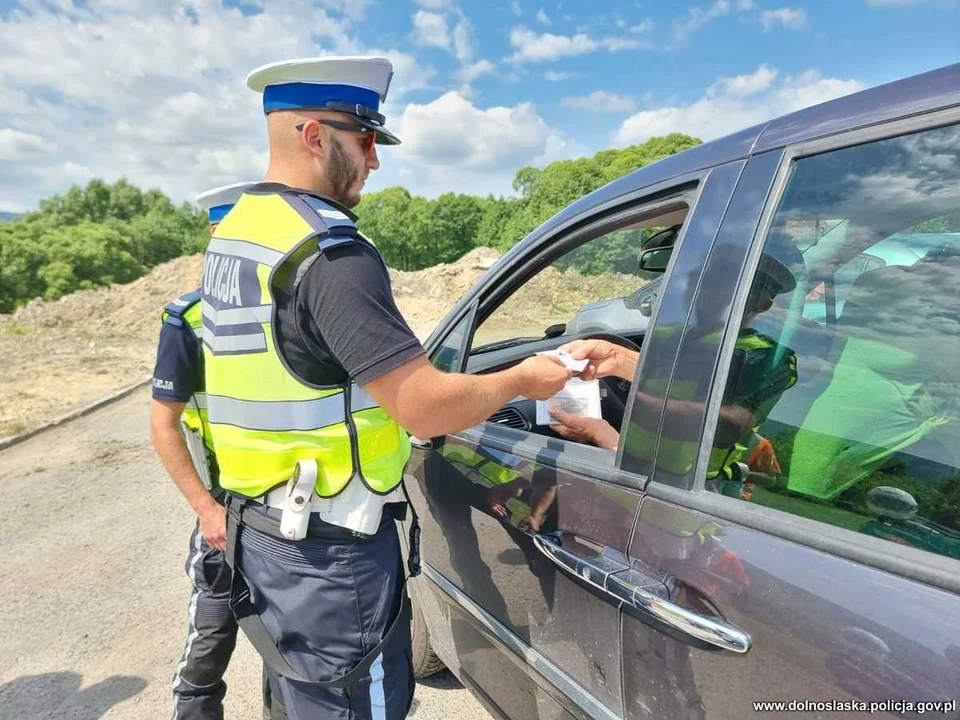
[668,107,960,592]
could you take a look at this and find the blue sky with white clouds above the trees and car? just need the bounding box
[0,0,960,211]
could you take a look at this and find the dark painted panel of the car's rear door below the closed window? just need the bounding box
[623,496,960,718]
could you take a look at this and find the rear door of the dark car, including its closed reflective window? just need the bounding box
[622,112,960,718]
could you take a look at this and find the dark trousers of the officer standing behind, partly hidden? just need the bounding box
[173,521,237,720]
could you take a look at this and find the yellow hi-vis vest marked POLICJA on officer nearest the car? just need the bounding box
[201,191,410,497]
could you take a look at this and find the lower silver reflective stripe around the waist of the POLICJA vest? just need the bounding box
[207,393,344,432]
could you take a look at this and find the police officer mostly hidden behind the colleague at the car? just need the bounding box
[150,183,251,720]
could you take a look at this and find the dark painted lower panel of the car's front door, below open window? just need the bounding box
[405,433,640,718]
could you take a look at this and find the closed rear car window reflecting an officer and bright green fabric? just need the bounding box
[705,126,960,559]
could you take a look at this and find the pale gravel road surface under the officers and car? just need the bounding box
[0,388,489,720]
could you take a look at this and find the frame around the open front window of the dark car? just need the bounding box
[427,174,710,490]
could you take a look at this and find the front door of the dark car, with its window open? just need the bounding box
[406,162,743,719]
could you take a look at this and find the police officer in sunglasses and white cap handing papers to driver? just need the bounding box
[201,57,570,719]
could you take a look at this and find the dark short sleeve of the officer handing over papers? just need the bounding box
[297,240,424,385]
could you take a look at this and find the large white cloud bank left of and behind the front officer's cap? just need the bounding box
[0,0,435,209]
